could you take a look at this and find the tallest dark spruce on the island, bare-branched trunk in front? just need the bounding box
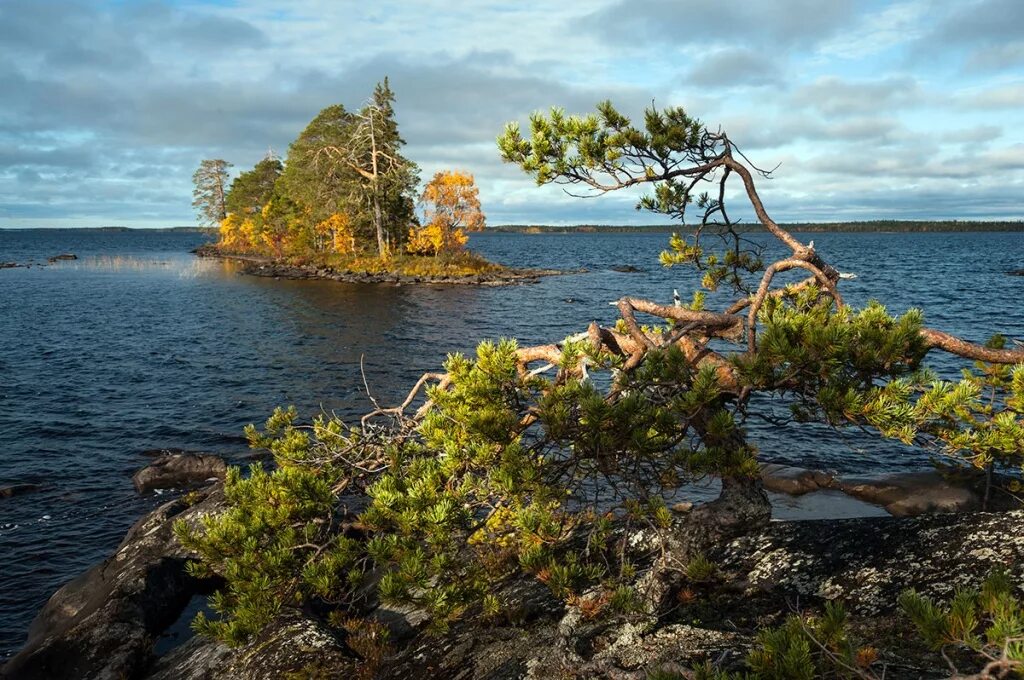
[314,78,419,258]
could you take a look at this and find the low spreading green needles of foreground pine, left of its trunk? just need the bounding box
[178,333,753,643]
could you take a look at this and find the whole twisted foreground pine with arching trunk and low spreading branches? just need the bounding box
[178,99,1024,642]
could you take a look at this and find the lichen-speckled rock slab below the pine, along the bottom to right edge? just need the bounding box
[144,512,1024,680]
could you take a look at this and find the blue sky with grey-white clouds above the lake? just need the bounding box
[0,0,1024,227]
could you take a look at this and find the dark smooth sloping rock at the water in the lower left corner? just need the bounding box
[0,485,223,680]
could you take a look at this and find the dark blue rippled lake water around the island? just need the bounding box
[0,229,1024,657]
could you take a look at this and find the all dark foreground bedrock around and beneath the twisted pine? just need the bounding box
[0,454,1024,680]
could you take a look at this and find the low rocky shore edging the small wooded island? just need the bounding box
[193,244,586,286]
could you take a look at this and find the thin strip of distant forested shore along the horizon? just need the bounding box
[0,219,1024,236]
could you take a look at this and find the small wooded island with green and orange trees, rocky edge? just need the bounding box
[193,78,561,286]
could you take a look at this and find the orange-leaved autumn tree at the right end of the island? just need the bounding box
[407,170,486,255]
